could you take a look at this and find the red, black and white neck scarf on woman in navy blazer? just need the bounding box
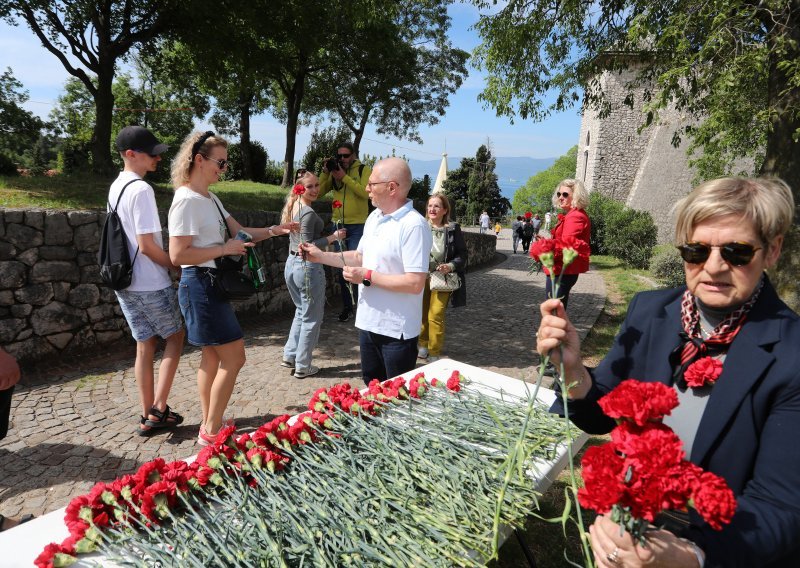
[670,277,764,381]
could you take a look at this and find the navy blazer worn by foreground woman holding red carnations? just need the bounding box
[551,276,800,568]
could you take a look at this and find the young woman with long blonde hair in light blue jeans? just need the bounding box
[281,171,347,379]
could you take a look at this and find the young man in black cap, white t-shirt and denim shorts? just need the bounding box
[108,126,184,436]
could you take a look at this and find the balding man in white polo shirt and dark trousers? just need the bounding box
[301,158,432,383]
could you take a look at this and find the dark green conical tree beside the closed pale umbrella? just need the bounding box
[443,145,511,224]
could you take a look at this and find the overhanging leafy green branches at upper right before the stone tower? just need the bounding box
[473,0,800,308]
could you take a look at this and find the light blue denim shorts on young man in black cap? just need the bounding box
[117,286,183,341]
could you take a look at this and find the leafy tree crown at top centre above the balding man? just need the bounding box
[312,0,469,151]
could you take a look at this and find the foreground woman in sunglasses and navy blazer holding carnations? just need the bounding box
[536,178,800,568]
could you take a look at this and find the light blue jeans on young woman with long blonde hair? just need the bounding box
[283,254,325,371]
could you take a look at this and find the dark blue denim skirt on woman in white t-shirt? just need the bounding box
[178,266,244,347]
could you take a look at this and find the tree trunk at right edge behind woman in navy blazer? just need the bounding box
[760,12,800,312]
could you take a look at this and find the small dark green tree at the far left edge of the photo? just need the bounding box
[0,68,45,161]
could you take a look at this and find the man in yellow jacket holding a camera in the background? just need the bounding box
[319,142,372,322]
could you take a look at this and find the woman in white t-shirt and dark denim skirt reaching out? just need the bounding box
[169,132,296,446]
